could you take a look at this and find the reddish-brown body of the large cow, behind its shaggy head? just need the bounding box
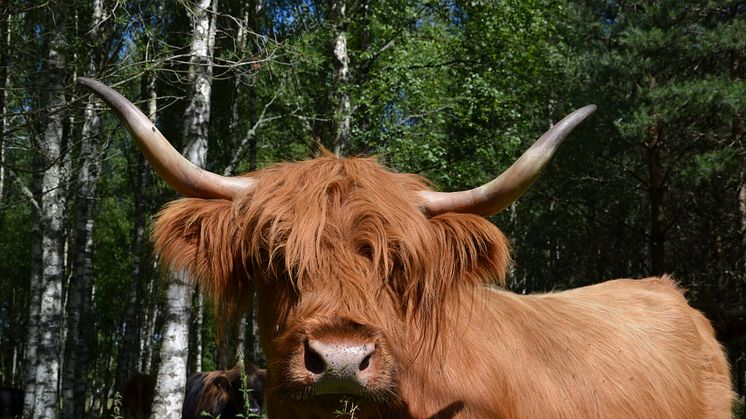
[406,277,732,419]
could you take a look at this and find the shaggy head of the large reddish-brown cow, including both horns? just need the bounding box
[81,79,595,414]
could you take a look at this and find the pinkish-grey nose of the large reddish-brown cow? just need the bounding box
[304,339,376,394]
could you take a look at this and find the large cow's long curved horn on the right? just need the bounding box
[420,105,596,216]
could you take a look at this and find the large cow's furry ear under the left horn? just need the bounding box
[153,198,251,311]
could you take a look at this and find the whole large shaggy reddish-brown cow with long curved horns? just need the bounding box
[81,80,732,419]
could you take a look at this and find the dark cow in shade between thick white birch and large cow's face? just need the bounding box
[181,364,266,419]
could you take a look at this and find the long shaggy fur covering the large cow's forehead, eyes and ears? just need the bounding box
[153,154,510,324]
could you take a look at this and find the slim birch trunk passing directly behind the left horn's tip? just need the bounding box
[62,0,104,418]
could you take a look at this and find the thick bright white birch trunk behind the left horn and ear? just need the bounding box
[151,0,217,419]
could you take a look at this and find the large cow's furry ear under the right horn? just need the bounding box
[431,213,512,286]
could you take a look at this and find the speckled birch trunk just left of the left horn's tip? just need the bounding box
[32,7,67,419]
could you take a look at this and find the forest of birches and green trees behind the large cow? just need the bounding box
[0,0,746,418]
